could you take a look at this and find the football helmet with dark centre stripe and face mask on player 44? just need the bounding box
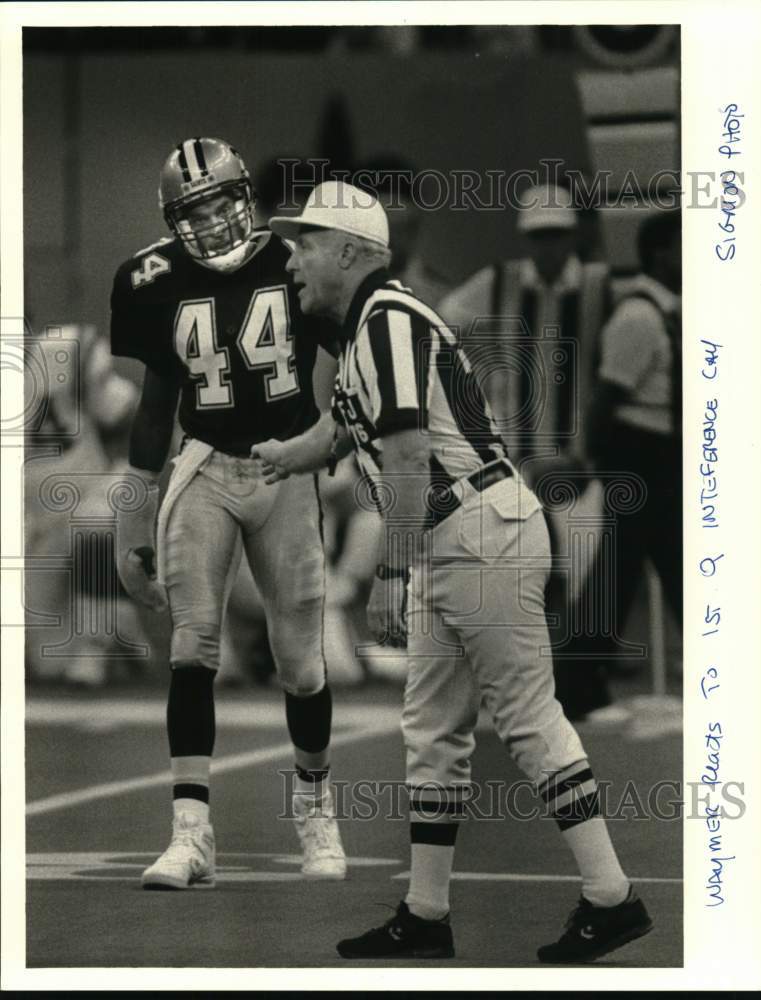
[159,138,256,270]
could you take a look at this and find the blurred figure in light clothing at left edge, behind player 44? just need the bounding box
[24,325,146,686]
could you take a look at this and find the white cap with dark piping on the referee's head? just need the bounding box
[269,181,388,247]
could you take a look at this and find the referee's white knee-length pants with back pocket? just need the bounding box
[402,481,586,788]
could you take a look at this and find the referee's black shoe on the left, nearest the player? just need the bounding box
[336,902,454,958]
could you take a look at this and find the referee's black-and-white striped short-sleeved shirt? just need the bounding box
[333,269,507,494]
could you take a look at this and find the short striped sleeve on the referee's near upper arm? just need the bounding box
[357,309,432,437]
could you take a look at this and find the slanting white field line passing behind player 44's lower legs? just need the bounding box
[26,720,397,816]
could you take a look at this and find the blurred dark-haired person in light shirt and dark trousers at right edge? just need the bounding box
[558,211,682,719]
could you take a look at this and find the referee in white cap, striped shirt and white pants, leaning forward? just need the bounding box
[253,182,652,963]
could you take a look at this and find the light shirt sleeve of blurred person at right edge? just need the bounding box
[598,299,662,391]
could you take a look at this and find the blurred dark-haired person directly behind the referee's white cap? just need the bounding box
[354,154,449,309]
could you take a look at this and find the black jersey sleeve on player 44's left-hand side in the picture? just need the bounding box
[111,262,178,375]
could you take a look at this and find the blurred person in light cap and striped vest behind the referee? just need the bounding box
[439,185,609,672]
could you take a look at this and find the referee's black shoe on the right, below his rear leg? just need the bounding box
[537,889,653,965]
